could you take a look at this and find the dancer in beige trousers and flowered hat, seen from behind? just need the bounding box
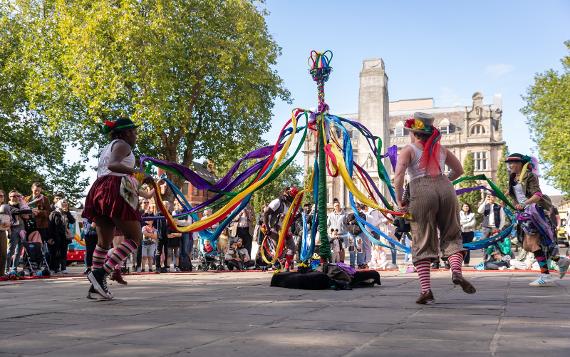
[394,112,476,304]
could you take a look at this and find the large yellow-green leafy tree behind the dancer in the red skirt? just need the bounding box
[7,0,289,189]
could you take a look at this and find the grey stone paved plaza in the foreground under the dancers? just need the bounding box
[0,271,570,357]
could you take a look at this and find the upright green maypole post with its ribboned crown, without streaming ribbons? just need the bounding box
[309,51,332,263]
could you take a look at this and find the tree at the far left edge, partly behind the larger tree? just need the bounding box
[0,1,87,200]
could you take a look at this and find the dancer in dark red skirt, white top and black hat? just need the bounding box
[82,119,154,300]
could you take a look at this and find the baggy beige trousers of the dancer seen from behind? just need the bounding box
[409,175,464,263]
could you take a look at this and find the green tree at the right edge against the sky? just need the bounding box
[521,41,570,194]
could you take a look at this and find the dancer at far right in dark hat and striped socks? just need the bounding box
[505,153,570,287]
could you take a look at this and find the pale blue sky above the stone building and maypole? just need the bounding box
[260,0,570,194]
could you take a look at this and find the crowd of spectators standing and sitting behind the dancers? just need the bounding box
[0,182,562,276]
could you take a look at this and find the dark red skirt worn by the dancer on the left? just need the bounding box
[81,175,141,222]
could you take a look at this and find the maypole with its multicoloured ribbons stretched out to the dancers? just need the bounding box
[141,51,516,264]
